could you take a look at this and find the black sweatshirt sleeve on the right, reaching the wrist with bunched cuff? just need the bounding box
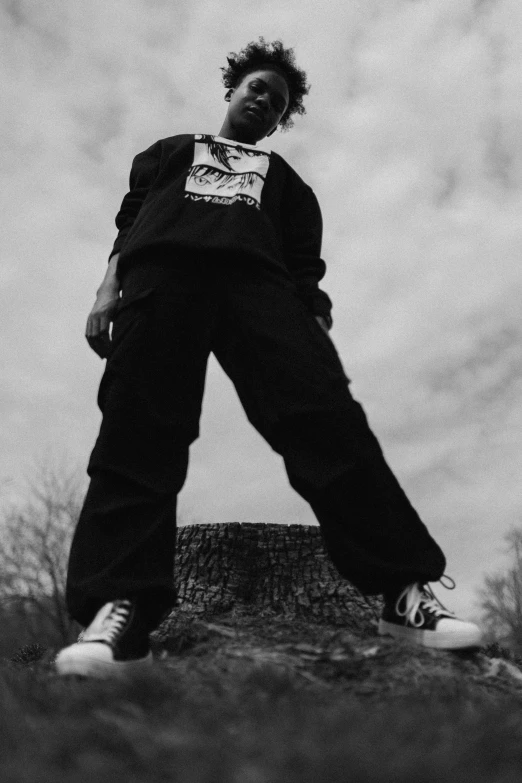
[283,182,333,329]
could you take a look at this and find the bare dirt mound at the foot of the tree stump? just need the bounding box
[149,612,522,700]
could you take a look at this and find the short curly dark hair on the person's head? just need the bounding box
[221,37,310,131]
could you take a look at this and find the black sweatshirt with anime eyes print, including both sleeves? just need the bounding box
[110,134,332,327]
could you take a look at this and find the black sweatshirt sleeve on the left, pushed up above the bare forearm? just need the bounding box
[109,142,161,261]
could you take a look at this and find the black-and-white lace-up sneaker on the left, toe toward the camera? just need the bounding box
[55,600,152,678]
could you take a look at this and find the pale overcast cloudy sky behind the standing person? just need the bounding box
[0,0,522,613]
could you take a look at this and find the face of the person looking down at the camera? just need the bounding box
[225,69,290,144]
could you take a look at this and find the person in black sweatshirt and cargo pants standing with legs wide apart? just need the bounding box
[56,38,481,676]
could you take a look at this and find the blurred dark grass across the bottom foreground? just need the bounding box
[0,649,522,783]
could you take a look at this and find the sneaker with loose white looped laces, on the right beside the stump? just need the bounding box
[379,583,482,650]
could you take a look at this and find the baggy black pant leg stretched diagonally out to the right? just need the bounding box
[213,270,445,594]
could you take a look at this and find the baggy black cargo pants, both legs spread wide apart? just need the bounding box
[67,258,445,628]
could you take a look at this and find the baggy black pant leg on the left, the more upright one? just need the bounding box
[67,262,217,628]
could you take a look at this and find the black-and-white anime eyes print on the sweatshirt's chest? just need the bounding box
[185,134,270,209]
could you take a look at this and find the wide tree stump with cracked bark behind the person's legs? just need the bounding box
[162,522,382,635]
